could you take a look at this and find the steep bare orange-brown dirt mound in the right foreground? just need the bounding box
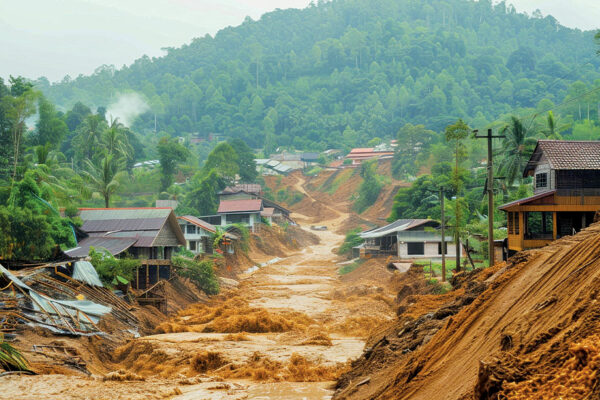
[335,224,600,399]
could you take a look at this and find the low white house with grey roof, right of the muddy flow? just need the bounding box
[359,219,456,259]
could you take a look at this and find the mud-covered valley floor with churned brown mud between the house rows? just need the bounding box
[0,174,408,399]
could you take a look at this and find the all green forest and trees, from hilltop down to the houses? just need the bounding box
[0,0,600,264]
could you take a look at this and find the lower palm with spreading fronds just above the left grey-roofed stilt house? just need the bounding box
[83,155,127,208]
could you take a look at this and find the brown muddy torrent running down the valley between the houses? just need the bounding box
[0,195,393,399]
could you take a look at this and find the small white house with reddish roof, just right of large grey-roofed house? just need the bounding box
[177,215,239,254]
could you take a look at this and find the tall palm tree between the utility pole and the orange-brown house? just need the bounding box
[501,116,537,186]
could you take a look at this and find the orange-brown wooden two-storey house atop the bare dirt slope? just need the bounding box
[500,140,600,256]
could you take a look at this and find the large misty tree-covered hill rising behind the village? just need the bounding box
[36,0,600,150]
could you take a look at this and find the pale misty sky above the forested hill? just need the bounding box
[0,0,600,81]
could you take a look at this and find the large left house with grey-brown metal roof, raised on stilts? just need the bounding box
[65,207,186,289]
